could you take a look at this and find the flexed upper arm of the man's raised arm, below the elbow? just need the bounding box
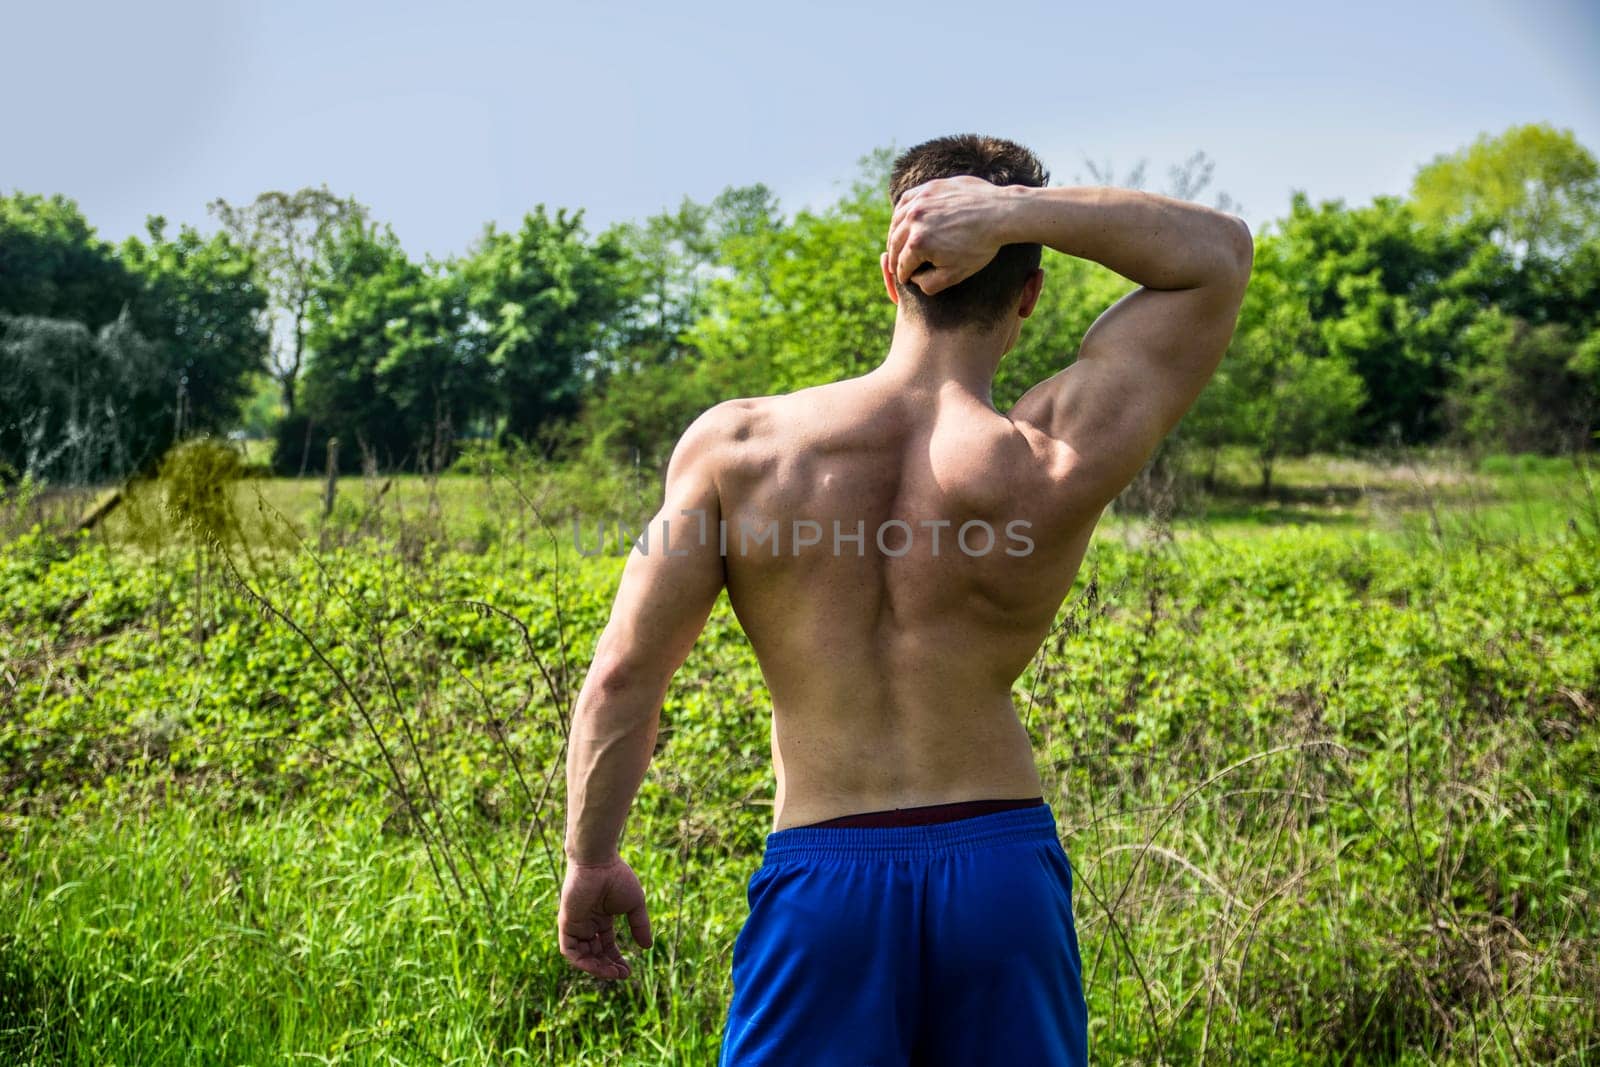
[1014,288,1238,499]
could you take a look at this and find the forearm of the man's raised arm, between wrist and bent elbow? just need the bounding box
[998,186,1251,290]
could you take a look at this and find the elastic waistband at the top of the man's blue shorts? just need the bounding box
[763,805,1061,864]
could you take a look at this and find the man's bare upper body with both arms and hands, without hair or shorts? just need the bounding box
[560,139,1251,977]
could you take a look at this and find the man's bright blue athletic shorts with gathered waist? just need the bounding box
[722,805,1088,1067]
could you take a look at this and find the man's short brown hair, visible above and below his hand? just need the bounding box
[890,133,1050,330]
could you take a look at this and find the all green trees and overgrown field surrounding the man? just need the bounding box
[0,126,1600,1064]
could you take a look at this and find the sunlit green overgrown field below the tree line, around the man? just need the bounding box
[0,456,1600,1065]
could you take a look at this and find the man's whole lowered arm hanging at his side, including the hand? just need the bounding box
[557,408,726,979]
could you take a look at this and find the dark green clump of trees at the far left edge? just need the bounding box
[0,194,266,482]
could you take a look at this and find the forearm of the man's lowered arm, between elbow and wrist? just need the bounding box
[566,673,661,864]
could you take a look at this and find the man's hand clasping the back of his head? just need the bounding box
[888,176,1027,296]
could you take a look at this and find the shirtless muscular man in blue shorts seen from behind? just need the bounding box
[558,136,1251,1067]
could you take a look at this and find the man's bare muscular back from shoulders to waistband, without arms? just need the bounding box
[718,365,1098,829]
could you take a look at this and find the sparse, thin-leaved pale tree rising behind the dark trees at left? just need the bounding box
[210,186,366,414]
